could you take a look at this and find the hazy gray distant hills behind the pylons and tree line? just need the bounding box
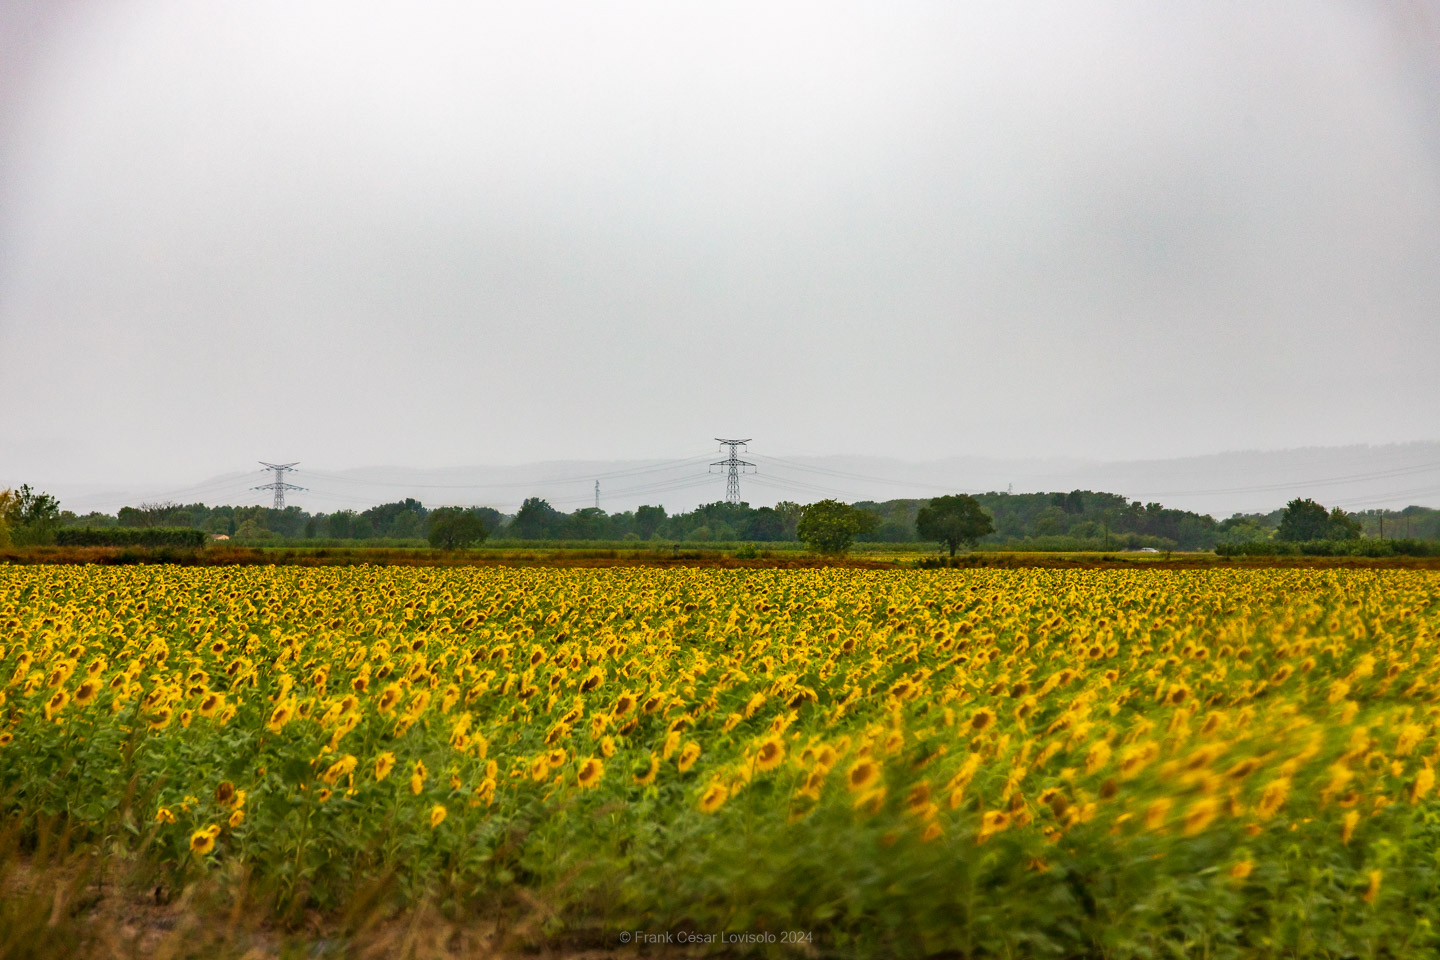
[45,442,1440,518]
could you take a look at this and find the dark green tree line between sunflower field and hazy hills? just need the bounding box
[8,486,1440,550]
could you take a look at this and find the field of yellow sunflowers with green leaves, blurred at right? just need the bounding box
[0,566,1440,957]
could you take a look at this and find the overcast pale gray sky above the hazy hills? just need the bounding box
[0,0,1440,503]
